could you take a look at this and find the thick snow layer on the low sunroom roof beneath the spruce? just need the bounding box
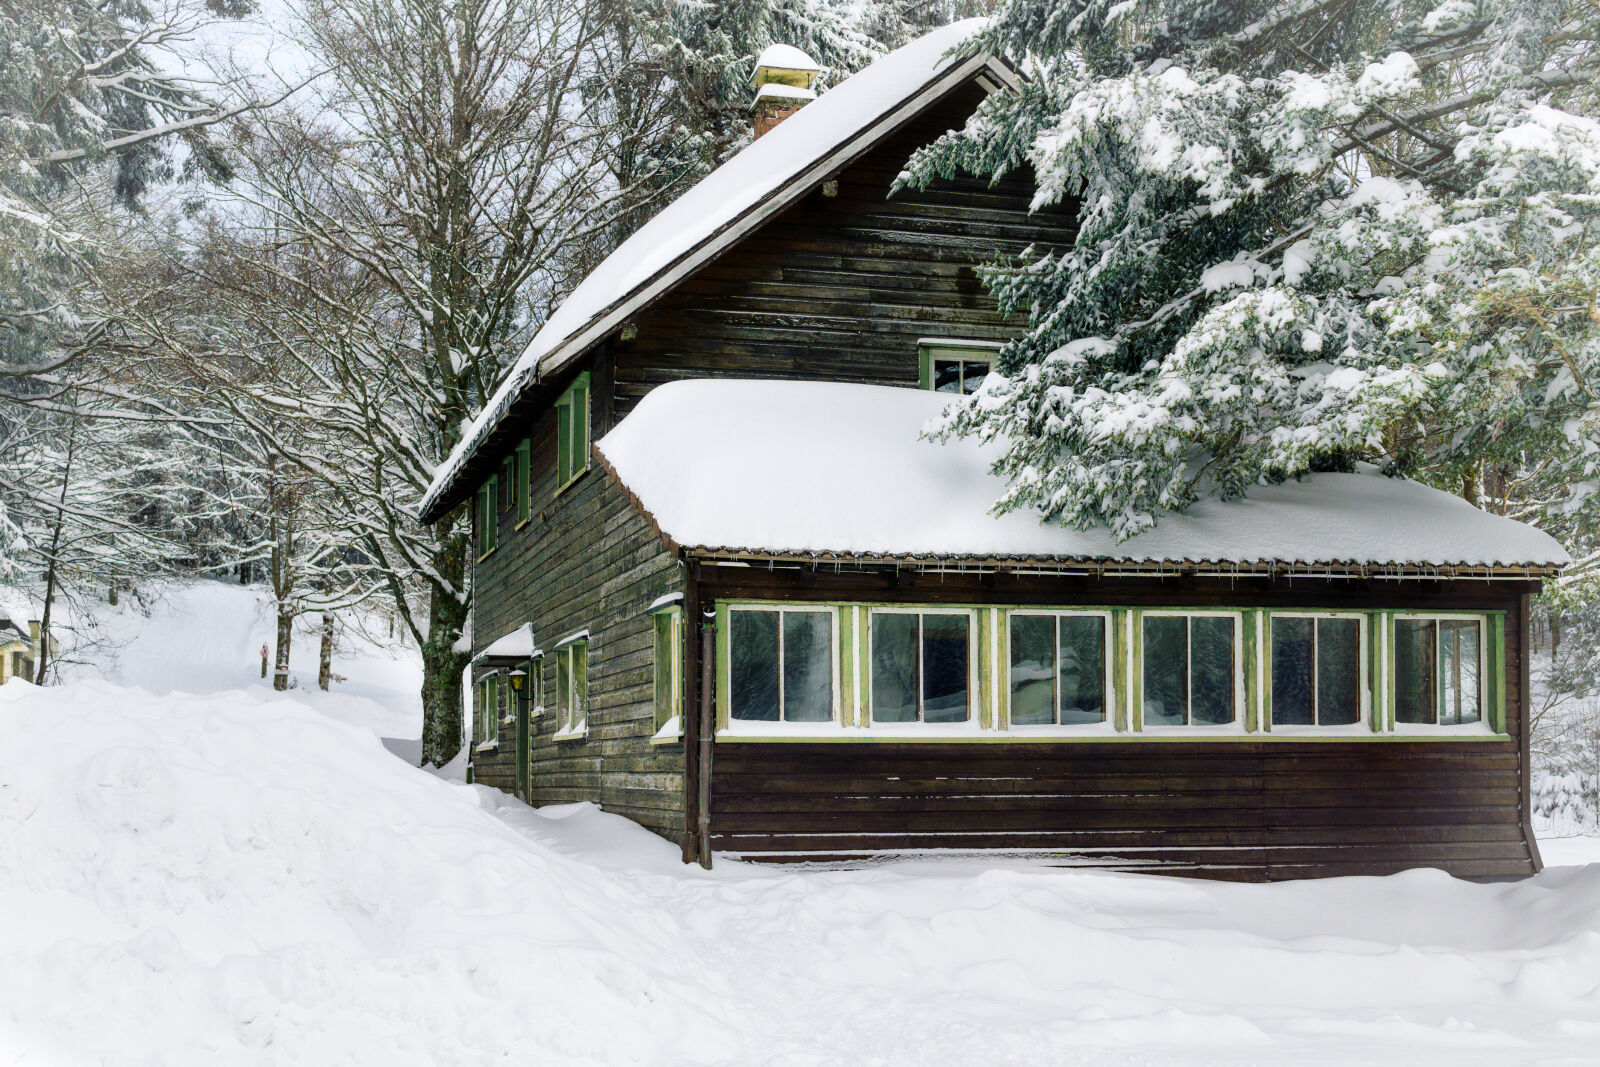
[598,381,1568,566]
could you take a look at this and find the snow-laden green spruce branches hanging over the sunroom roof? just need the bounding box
[902,0,1600,579]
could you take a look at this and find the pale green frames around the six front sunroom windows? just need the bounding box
[713,598,1510,742]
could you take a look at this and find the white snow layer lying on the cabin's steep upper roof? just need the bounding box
[421,19,986,512]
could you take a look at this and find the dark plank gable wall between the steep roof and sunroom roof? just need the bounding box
[616,85,1075,418]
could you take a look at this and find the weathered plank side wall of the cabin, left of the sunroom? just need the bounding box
[472,368,683,843]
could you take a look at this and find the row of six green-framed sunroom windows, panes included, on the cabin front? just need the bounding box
[720,605,1504,733]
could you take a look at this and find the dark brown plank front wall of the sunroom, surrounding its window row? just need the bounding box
[706,568,1533,880]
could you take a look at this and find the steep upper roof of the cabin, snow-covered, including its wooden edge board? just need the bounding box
[419,19,1014,517]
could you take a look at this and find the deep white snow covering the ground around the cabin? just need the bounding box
[0,593,1600,1067]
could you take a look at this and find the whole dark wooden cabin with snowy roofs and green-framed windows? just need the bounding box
[422,24,1566,880]
